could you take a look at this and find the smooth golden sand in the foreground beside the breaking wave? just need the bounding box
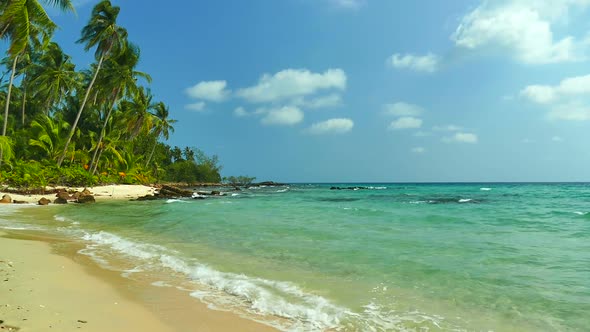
[0,230,276,332]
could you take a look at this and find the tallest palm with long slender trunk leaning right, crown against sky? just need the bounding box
[57,0,127,167]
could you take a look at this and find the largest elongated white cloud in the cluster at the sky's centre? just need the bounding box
[237,69,346,103]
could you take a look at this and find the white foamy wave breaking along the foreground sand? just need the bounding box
[79,231,454,331]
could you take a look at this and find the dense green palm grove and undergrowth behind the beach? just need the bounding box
[0,0,221,187]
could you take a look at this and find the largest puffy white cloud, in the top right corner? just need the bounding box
[452,0,590,64]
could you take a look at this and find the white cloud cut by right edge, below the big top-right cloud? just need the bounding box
[520,75,590,104]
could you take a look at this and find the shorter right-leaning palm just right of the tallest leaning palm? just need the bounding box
[90,43,152,173]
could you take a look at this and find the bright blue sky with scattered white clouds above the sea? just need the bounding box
[47,0,590,182]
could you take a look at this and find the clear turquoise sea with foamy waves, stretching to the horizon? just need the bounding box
[3,184,590,331]
